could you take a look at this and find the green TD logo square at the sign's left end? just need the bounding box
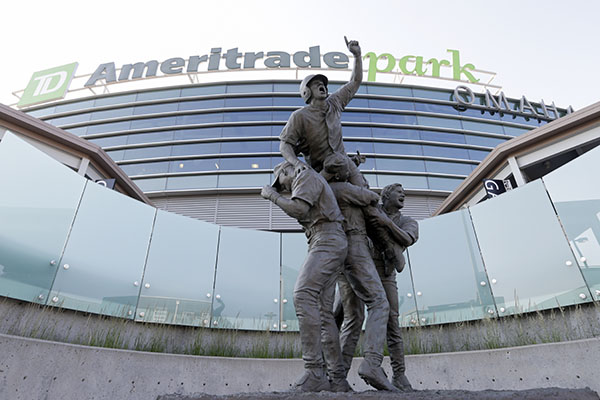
[17,63,78,107]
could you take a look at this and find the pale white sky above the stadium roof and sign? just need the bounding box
[0,0,600,110]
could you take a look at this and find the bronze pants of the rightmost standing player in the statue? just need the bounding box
[338,265,406,376]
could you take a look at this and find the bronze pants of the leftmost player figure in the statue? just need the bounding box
[294,222,348,379]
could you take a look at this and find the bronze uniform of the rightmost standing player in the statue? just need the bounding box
[342,208,419,376]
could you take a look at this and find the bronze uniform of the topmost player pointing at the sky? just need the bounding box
[279,81,363,185]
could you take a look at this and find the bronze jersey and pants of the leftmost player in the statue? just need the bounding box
[292,168,348,379]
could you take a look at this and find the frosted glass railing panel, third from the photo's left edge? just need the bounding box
[136,210,219,326]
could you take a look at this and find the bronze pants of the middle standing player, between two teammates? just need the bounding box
[338,235,390,373]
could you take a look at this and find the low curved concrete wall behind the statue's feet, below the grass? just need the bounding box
[0,334,600,400]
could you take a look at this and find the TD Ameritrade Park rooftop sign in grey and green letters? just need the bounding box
[17,46,480,107]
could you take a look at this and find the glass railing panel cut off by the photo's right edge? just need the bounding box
[543,146,600,299]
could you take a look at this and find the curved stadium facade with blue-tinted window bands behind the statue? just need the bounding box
[26,81,566,231]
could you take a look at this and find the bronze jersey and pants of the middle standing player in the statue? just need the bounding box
[330,182,389,373]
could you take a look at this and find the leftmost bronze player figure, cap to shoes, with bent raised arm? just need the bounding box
[261,161,352,392]
